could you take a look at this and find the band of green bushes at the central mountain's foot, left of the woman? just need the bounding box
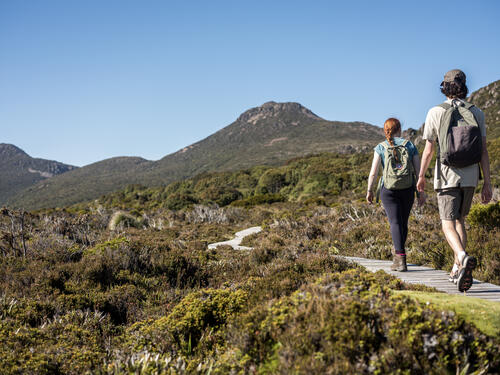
[90,153,371,210]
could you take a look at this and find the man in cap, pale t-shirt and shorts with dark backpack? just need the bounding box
[417,69,492,292]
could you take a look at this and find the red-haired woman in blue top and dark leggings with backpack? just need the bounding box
[366,118,425,271]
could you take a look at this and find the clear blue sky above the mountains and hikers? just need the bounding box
[0,0,500,166]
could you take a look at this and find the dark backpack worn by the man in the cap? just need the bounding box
[438,100,483,168]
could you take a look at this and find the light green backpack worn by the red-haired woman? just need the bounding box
[377,139,415,201]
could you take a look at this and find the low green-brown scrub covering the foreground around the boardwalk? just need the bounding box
[0,197,500,374]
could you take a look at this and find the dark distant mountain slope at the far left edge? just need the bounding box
[0,143,78,205]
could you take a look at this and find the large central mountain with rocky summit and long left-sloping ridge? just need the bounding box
[8,101,383,209]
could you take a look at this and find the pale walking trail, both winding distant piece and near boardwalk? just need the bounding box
[208,226,500,302]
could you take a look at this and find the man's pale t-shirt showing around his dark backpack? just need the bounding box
[422,99,486,190]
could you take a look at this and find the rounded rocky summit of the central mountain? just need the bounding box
[237,101,322,124]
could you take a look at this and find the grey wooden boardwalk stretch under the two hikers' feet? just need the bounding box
[342,256,500,302]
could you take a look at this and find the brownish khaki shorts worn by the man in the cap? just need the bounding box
[437,187,475,220]
